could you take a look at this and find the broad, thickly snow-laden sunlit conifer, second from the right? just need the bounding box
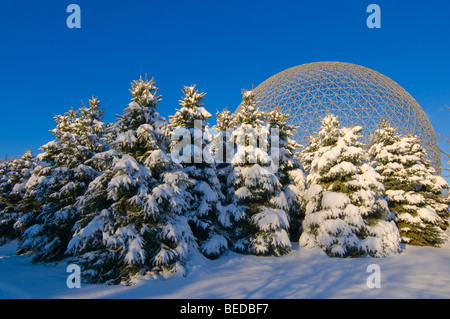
[300,114,400,257]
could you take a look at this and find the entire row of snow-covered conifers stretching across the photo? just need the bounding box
[0,78,449,283]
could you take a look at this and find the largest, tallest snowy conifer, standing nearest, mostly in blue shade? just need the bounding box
[68,78,194,284]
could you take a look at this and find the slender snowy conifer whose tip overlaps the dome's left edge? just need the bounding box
[227,90,291,256]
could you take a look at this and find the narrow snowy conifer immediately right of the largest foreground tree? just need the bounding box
[170,85,228,258]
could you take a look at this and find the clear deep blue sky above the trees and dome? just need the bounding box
[0,0,450,172]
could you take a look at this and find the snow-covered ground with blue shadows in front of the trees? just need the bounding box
[0,242,450,299]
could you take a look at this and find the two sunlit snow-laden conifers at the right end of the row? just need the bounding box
[300,115,449,257]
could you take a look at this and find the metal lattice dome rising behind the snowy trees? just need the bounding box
[236,62,440,170]
